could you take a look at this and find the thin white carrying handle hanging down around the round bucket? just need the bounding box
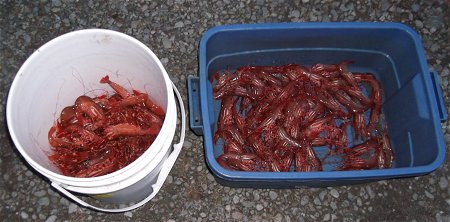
[51,82,186,213]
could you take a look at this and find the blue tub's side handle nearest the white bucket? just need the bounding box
[187,75,203,136]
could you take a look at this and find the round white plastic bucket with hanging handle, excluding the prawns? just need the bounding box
[6,29,185,212]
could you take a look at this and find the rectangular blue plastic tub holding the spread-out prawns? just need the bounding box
[188,22,447,188]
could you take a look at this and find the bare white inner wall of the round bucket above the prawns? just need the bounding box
[8,30,171,174]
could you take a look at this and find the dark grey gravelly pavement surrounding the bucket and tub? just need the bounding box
[0,0,450,222]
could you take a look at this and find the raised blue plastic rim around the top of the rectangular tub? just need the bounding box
[199,22,445,181]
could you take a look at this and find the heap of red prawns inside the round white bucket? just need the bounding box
[48,76,165,177]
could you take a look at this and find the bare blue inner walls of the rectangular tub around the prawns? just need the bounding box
[201,24,439,171]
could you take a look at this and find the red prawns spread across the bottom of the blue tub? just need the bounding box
[212,61,394,172]
